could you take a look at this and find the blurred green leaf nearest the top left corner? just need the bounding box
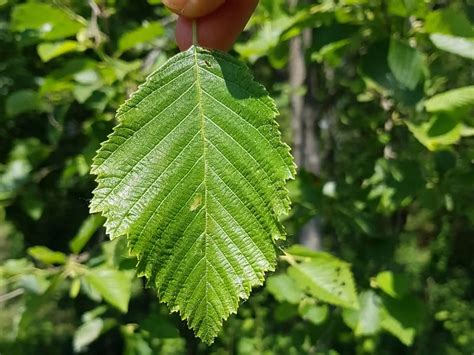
[11,2,85,40]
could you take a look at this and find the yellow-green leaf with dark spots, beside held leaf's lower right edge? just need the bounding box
[287,249,358,308]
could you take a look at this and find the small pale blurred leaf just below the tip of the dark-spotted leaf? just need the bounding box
[342,290,381,336]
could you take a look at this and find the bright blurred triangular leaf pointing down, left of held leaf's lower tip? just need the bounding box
[84,267,132,313]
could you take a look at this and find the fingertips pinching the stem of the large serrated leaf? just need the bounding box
[163,0,258,51]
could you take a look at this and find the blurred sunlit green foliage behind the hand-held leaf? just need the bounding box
[0,0,474,354]
